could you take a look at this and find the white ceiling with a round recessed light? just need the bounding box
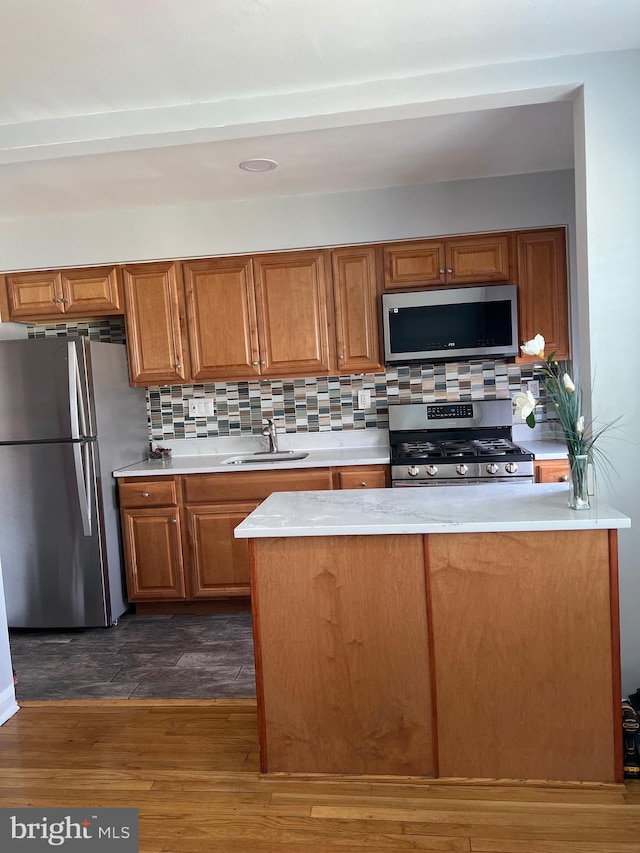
[0,0,640,218]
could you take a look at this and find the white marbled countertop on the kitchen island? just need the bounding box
[234,483,631,539]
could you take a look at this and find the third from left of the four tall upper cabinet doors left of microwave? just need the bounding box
[253,251,334,376]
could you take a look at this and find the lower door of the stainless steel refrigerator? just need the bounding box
[0,443,111,628]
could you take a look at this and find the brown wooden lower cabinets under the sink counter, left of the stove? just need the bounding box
[118,465,388,603]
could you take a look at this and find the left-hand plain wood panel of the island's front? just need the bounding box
[252,536,437,776]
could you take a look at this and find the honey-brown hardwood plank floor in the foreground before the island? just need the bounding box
[0,699,640,853]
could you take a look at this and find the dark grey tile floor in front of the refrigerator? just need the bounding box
[9,613,256,702]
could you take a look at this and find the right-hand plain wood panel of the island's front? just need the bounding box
[427,530,619,782]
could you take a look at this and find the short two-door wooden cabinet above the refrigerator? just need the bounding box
[4,266,124,323]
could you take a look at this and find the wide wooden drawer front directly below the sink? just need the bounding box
[184,468,332,503]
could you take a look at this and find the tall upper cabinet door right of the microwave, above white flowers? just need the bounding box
[516,228,570,361]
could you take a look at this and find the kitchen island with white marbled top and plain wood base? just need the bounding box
[235,484,630,782]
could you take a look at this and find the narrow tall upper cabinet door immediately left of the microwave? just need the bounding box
[331,247,384,373]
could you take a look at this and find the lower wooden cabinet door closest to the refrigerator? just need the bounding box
[122,507,185,601]
